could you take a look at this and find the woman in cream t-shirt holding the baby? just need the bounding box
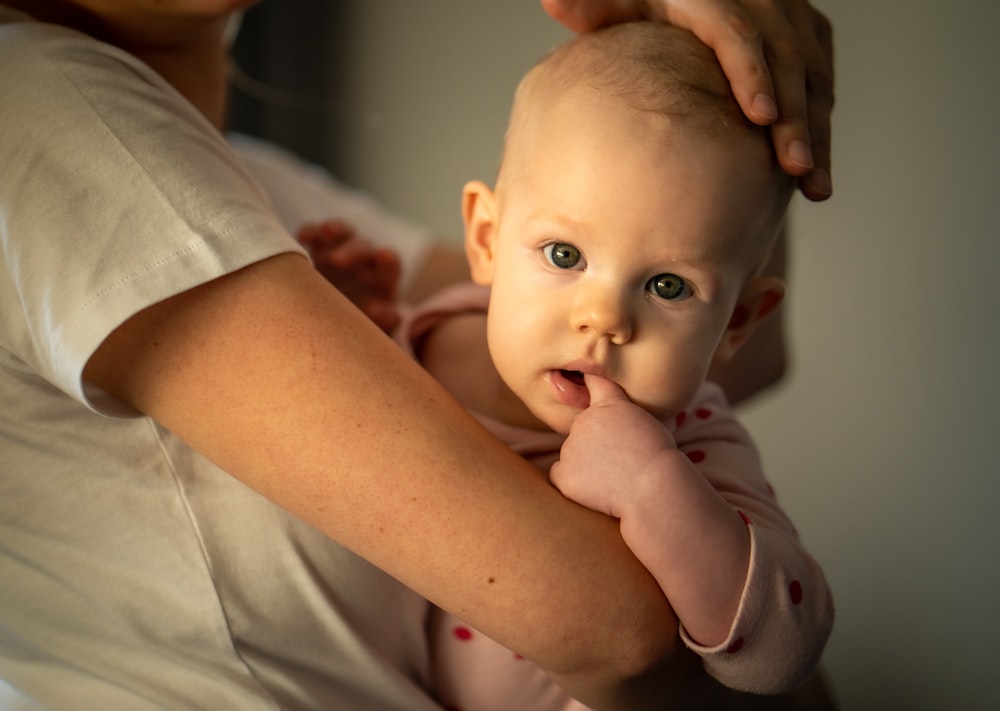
[0,0,829,709]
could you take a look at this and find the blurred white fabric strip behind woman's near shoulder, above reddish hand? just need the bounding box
[228,132,432,293]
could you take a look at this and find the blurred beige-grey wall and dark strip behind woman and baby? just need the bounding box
[233,0,1000,711]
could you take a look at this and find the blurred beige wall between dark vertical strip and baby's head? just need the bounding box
[320,0,568,239]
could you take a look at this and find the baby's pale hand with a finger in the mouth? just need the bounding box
[549,375,677,518]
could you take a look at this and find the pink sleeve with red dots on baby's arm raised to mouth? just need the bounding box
[672,384,834,693]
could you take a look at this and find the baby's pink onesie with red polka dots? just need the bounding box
[397,284,834,711]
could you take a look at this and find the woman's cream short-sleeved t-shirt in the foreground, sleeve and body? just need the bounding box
[0,8,436,711]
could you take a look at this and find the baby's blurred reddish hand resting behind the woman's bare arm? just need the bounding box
[296,220,401,333]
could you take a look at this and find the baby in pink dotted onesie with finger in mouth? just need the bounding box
[401,23,833,711]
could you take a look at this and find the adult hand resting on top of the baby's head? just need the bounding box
[542,0,833,200]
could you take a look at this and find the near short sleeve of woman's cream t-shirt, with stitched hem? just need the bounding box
[0,23,301,414]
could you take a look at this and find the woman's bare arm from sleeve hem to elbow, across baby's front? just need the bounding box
[84,254,676,699]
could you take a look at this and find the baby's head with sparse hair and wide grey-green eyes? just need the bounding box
[463,23,794,431]
